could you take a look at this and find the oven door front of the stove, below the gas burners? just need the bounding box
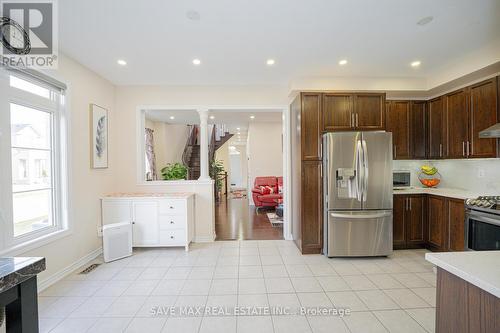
[465,211,500,251]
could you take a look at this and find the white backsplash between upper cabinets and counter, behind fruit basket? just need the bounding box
[393,158,500,195]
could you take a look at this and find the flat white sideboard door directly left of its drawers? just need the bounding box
[132,200,159,246]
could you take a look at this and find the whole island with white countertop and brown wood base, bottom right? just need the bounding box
[425,251,500,333]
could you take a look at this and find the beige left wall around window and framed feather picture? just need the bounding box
[17,55,116,281]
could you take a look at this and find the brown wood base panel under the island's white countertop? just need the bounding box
[436,267,500,333]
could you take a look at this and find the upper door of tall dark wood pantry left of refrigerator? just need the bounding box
[300,93,321,161]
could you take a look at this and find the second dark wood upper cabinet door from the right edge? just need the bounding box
[446,88,469,158]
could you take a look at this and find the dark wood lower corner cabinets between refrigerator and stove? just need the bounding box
[393,194,465,251]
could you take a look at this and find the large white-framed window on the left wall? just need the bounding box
[0,69,67,250]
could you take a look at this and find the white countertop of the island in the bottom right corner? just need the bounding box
[425,251,500,298]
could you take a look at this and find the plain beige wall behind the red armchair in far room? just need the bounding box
[247,122,283,204]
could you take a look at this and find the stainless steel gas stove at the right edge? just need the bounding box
[465,196,500,251]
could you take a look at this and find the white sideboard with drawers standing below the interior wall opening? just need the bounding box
[101,193,195,251]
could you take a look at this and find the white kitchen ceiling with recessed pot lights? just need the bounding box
[59,0,500,85]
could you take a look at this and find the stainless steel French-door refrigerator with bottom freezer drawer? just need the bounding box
[323,131,393,257]
